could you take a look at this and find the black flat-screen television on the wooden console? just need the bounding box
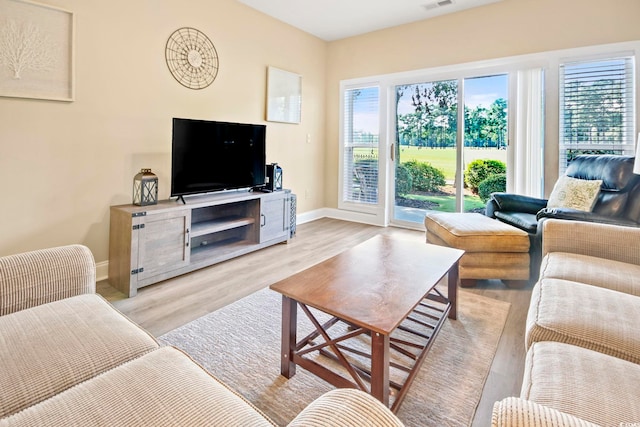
[171,118,266,197]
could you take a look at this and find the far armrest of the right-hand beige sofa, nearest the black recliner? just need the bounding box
[542,219,640,265]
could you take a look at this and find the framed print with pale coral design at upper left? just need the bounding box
[0,0,74,101]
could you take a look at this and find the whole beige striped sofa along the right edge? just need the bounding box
[493,219,640,427]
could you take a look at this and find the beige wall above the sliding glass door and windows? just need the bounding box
[325,0,640,208]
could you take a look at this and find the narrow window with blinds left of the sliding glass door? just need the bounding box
[341,87,380,205]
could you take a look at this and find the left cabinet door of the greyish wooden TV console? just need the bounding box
[138,209,191,280]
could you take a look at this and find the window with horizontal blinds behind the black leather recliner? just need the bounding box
[559,57,635,174]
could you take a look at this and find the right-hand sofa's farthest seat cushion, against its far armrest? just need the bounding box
[540,252,640,296]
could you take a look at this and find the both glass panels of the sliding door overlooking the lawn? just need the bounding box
[392,74,508,223]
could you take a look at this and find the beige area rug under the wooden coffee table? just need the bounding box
[160,289,510,427]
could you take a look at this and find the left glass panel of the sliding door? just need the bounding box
[393,80,459,223]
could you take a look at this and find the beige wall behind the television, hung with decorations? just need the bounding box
[0,0,326,262]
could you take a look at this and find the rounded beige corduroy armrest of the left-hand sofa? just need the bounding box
[0,245,96,316]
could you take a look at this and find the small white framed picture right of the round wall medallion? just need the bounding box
[267,67,302,123]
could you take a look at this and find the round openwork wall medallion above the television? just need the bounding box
[165,27,218,89]
